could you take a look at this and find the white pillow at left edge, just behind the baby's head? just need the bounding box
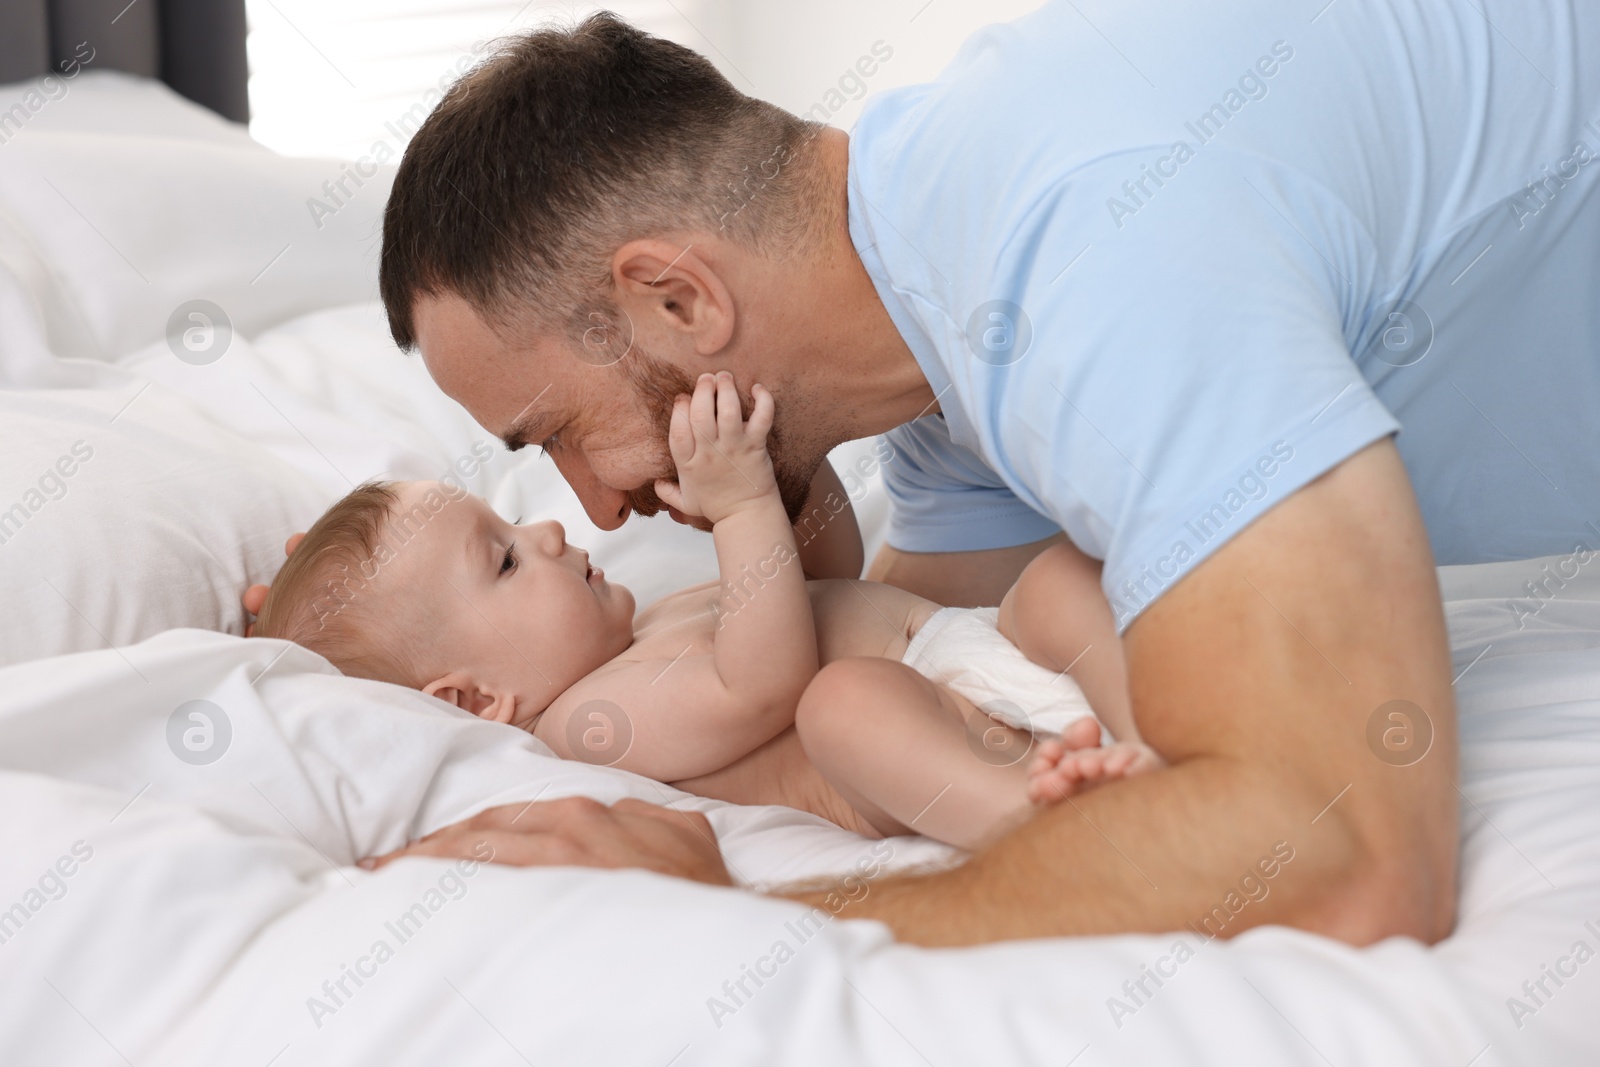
[0,379,331,664]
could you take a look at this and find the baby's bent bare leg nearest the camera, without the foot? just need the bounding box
[795,659,1035,849]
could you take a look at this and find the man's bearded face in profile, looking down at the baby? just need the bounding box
[414,294,812,530]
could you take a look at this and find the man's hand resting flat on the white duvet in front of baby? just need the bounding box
[360,797,733,886]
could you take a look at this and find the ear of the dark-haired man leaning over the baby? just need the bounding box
[611,238,734,355]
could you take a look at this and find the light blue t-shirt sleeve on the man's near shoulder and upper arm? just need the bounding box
[941,146,1398,630]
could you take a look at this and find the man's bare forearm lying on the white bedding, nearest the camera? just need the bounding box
[787,758,1355,945]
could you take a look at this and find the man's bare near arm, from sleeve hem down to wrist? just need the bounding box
[797,438,1458,945]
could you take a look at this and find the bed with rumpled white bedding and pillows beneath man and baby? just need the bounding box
[0,69,1600,1067]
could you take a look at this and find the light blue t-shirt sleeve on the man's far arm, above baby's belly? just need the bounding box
[883,414,1059,552]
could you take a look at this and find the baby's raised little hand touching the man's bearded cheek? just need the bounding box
[656,371,779,523]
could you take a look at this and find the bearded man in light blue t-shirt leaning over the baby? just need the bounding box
[363,0,1600,944]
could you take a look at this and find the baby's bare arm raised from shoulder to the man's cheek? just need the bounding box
[536,373,818,782]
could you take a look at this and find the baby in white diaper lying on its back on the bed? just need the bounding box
[254,373,1160,848]
